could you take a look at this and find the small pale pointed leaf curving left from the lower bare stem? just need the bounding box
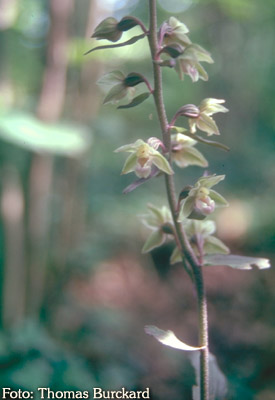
[144,325,205,351]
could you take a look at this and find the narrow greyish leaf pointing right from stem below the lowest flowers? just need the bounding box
[204,254,270,270]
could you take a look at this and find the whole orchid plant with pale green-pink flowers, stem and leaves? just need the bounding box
[86,0,270,400]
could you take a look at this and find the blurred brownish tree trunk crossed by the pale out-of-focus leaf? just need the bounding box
[28,0,74,316]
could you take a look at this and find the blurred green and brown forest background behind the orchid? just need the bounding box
[0,0,275,400]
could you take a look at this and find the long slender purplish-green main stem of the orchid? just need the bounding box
[148,0,209,400]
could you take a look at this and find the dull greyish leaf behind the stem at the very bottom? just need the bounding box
[190,352,228,400]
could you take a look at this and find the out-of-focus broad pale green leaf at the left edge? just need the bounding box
[0,112,91,157]
